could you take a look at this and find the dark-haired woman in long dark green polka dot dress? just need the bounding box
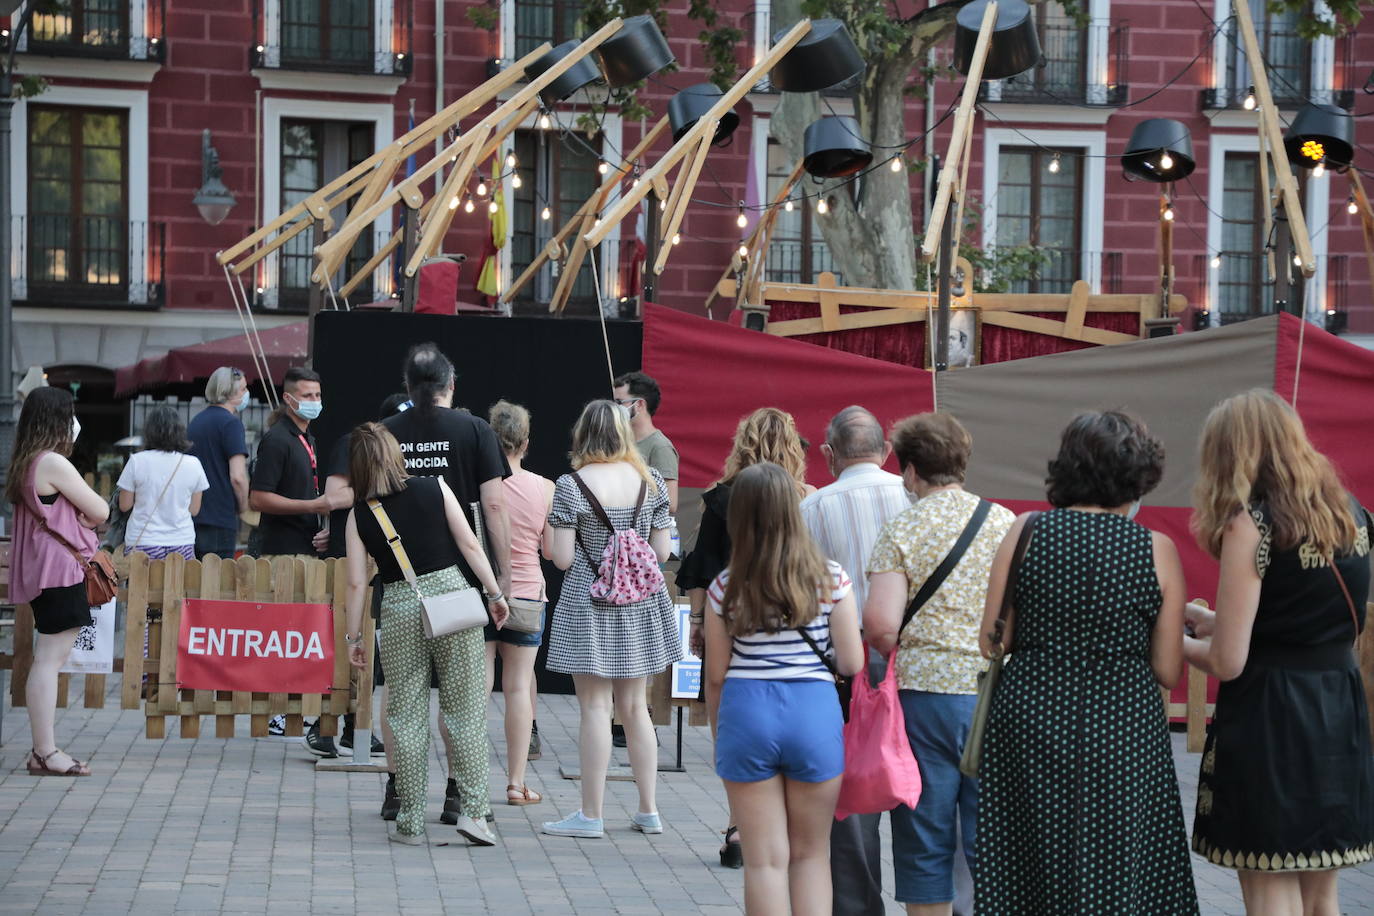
[974,412,1198,916]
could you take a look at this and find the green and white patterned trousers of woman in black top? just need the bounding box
[382,566,491,836]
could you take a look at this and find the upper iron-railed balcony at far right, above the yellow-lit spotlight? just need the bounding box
[1202,25,1355,111]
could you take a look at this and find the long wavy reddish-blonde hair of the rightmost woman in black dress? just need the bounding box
[1193,389,1359,559]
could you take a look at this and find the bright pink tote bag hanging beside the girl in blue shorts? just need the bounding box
[835,645,921,820]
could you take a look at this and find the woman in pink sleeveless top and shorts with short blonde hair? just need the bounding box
[486,401,554,805]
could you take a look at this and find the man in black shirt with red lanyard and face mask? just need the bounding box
[249,367,330,558]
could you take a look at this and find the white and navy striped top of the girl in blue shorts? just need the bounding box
[706,560,853,681]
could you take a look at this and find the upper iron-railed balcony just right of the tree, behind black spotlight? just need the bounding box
[978,22,1131,106]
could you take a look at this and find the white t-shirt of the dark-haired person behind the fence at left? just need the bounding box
[118,452,210,547]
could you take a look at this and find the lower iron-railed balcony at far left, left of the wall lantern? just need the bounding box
[10,214,166,309]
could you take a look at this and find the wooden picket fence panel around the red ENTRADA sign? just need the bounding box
[121,551,372,737]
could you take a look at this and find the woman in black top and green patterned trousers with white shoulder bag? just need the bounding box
[345,423,508,846]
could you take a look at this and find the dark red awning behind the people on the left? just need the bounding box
[114,321,309,397]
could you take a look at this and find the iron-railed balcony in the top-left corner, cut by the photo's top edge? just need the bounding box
[0,0,166,63]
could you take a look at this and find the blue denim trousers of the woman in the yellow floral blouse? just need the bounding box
[892,689,978,904]
